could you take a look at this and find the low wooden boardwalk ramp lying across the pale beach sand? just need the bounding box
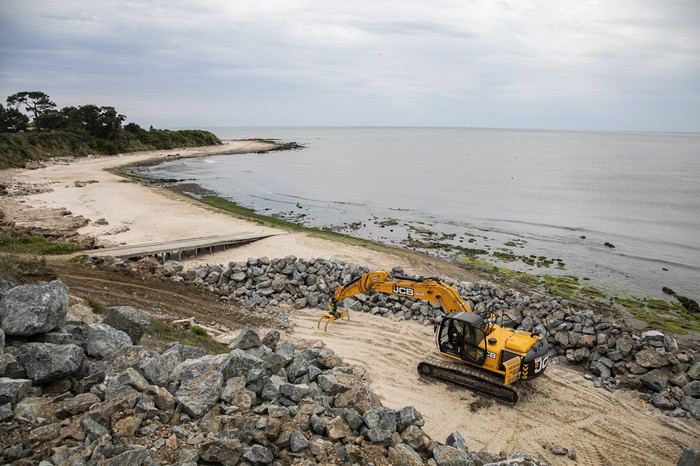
[84,232,274,261]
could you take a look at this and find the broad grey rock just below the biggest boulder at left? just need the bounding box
[17,343,83,383]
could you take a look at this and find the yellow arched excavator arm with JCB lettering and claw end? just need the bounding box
[317,271,471,330]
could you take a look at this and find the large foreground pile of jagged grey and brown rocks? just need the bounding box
[0,280,542,466]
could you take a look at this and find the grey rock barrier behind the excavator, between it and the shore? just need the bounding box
[93,256,700,419]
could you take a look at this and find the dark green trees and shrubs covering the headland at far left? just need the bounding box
[0,91,221,168]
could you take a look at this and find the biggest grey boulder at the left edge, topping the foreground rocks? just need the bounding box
[0,281,68,336]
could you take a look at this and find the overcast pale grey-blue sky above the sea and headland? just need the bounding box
[0,0,700,132]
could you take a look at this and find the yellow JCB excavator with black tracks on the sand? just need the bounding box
[318,271,549,403]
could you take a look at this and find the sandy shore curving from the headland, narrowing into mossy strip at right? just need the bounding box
[0,140,698,339]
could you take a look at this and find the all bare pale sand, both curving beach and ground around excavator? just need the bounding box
[0,141,700,465]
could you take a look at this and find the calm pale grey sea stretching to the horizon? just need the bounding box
[139,127,700,300]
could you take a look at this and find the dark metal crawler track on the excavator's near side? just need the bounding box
[418,357,522,403]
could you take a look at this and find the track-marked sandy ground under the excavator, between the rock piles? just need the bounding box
[293,310,700,466]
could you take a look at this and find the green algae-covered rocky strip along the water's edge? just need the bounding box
[121,147,700,341]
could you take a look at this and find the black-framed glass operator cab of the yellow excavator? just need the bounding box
[438,313,486,366]
